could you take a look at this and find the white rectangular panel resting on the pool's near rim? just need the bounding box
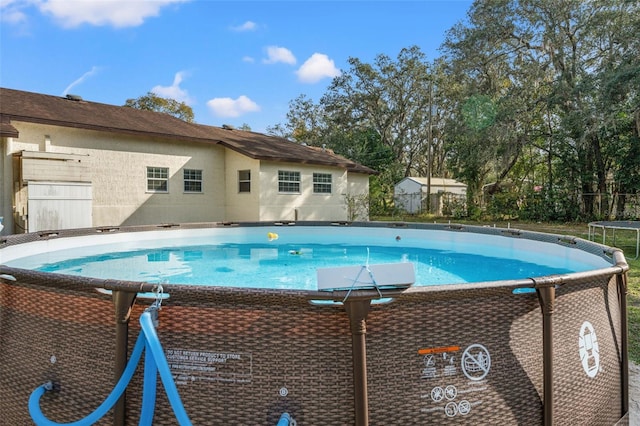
[316,262,416,290]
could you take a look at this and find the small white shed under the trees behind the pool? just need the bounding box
[393,177,467,214]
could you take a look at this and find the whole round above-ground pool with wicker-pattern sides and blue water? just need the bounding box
[0,222,628,425]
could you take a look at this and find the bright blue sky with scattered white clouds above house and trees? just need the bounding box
[0,0,472,132]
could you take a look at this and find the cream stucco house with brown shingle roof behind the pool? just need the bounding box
[0,88,375,234]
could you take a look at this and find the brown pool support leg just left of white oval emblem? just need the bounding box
[536,285,556,426]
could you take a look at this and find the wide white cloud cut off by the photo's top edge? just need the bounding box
[38,0,186,28]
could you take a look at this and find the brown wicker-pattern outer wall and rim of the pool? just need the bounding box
[0,222,628,425]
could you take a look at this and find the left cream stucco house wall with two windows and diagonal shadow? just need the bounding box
[4,122,225,231]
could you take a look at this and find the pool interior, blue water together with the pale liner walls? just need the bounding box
[0,226,609,290]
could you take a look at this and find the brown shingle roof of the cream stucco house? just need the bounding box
[0,88,376,174]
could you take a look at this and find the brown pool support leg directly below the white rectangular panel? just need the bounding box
[344,299,371,426]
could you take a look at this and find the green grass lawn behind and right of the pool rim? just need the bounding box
[374,217,640,364]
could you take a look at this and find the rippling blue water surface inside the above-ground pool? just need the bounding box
[10,244,571,290]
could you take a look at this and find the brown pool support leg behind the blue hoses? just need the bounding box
[111,290,136,426]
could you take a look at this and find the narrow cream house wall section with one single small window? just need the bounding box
[225,149,261,222]
